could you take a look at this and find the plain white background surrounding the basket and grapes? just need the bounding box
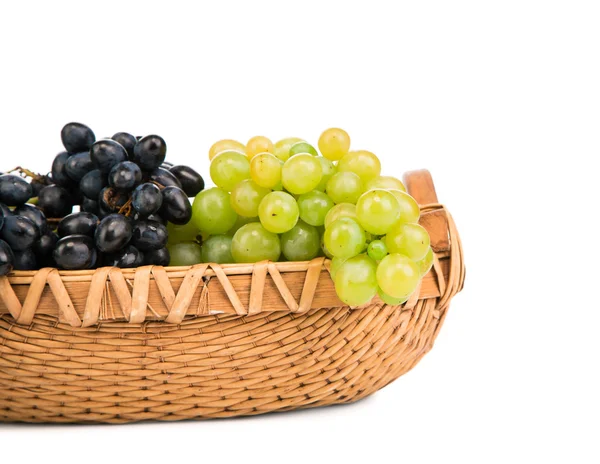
[0,0,600,464]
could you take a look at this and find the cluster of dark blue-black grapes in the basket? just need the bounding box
[0,123,204,275]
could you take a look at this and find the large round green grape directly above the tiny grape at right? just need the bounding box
[356,189,400,235]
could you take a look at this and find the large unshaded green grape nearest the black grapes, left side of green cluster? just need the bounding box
[192,187,238,235]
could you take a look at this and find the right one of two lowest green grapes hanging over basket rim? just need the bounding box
[377,253,421,298]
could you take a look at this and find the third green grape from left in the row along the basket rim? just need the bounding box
[231,222,281,263]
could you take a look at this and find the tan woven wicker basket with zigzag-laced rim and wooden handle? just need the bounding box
[0,171,464,423]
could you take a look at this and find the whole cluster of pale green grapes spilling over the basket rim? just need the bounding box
[168,128,433,306]
